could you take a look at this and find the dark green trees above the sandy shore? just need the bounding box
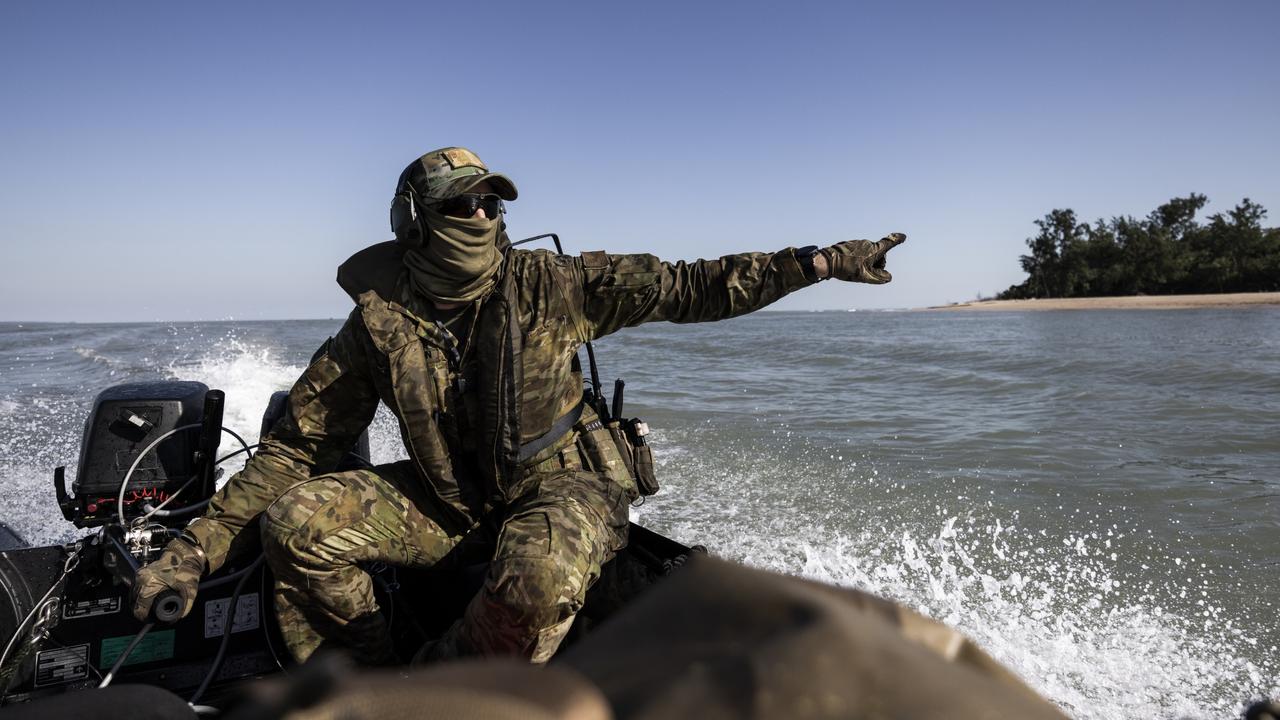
[997,193,1280,300]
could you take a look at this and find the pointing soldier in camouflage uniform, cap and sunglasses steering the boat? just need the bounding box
[133,147,905,664]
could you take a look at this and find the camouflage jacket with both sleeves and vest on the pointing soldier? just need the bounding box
[189,242,812,570]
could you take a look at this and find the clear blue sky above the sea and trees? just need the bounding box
[0,0,1280,322]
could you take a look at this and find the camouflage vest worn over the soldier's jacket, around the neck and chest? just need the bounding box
[338,242,581,523]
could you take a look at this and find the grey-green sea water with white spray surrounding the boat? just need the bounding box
[0,307,1280,717]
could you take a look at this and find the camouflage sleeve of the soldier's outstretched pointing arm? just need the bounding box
[581,247,813,340]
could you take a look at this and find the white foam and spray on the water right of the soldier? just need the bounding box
[644,430,1280,719]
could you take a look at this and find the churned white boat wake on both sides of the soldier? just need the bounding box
[0,326,1280,719]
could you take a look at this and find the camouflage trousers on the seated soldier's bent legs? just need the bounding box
[262,448,630,665]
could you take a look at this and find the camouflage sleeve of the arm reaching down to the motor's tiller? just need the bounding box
[188,310,378,571]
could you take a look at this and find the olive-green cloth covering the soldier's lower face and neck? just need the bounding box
[404,208,502,302]
